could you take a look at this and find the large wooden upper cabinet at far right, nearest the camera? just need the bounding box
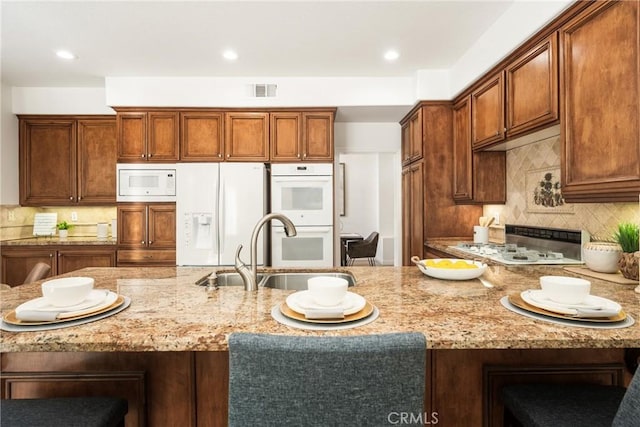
[560,1,640,202]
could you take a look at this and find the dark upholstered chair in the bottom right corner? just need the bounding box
[502,369,640,427]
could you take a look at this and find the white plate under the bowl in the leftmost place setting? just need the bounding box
[16,289,118,320]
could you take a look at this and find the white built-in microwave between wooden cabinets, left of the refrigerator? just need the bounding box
[116,163,176,202]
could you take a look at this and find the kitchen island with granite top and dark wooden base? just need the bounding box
[0,265,640,426]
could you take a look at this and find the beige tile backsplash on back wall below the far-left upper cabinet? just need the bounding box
[0,205,117,240]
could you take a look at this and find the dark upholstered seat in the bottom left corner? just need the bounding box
[0,397,129,427]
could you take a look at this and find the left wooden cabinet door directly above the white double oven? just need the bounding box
[270,112,302,162]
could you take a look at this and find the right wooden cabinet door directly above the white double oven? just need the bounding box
[302,112,333,162]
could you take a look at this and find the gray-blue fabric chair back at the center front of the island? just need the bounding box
[229,333,426,427]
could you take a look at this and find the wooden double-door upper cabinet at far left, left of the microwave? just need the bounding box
[18,115,116,206]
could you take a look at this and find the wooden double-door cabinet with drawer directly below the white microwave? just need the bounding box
[117,203,176,266]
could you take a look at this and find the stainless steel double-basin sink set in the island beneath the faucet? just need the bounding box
[198,271,356,291]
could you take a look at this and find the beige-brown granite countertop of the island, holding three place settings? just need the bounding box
[0,266,640,352]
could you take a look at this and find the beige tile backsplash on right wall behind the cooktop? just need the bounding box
[484,136,640,240]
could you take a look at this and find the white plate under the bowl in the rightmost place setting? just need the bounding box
[520,289,622,317]
